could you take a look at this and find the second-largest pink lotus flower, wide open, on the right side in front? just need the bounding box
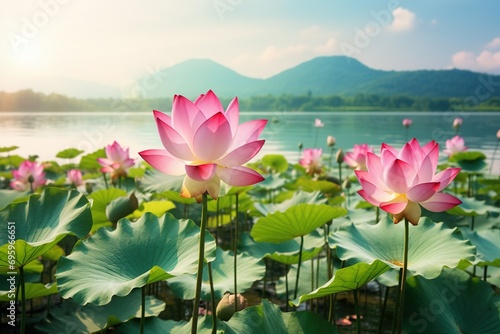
[355,139,461,225]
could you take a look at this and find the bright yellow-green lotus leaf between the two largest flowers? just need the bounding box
[251,204,347,243]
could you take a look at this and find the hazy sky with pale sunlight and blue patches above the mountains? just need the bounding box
[0,0,500,91]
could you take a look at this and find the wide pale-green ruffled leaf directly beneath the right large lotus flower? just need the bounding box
[329,218,475,279]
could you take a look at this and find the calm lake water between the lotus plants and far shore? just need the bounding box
[0,111,500,174]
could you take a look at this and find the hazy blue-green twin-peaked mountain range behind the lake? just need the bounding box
[139,56,500,98]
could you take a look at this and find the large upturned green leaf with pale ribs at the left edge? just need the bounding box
[0,187,92,270]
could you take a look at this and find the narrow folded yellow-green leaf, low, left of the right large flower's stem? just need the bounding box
[290,260,390,306]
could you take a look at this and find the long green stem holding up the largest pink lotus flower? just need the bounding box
[191,192,208,334]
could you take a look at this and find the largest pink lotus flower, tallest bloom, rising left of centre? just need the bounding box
[139,90,267,201]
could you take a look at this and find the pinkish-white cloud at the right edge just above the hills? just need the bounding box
[451,50,500,72]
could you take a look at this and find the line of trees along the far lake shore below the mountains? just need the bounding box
[0,90,500,111]
